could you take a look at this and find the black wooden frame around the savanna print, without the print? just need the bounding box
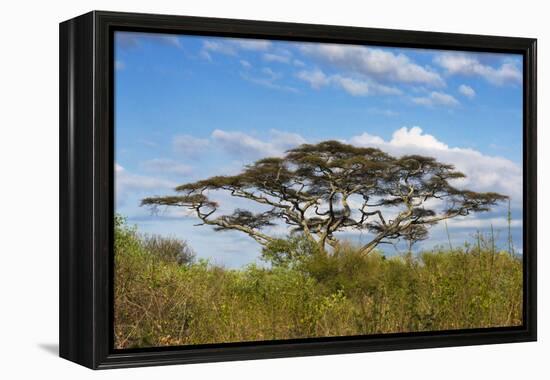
[59,11,537,369]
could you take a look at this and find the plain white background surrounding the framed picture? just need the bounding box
[0,0,550,380]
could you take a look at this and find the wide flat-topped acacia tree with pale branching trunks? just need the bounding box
[142,141,507,254]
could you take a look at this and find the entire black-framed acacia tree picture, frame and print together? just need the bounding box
[60,11,537,369]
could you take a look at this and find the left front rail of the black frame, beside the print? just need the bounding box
[93,12,115,368]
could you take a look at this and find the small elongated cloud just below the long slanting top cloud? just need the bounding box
[296,69,401,96]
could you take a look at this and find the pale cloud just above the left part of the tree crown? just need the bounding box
[212,129,306,159]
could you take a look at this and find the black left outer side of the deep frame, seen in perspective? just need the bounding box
[59,13,96,368]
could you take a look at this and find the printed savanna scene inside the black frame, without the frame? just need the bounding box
[113,32,523,349]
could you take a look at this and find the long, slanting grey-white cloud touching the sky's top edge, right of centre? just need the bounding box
[301,44,445,86]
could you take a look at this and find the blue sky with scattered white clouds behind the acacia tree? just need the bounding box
[115,32,522,267]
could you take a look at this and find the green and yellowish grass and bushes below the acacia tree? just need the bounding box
[115,218,522,348]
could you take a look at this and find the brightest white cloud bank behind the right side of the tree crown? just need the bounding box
[349,127,523,207]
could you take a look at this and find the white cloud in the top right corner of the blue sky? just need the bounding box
[434,53,523,86]
